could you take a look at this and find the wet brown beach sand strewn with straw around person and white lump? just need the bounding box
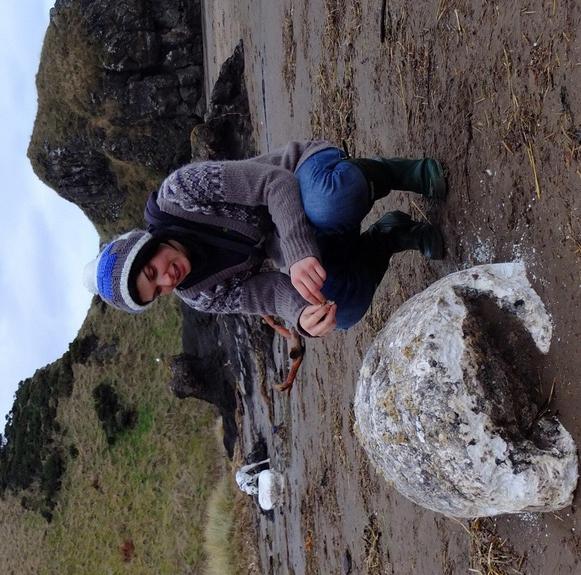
[207,0,581,575]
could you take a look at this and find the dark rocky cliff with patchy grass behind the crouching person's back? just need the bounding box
[28,0,205,231]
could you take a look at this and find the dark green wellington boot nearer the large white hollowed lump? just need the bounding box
[360,210,444,283]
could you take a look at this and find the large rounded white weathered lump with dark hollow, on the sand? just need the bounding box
[355,263,578,517]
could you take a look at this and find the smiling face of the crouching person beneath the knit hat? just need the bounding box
[136,240,192,304]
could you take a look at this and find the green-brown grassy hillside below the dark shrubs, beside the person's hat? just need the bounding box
[0,301,222,575]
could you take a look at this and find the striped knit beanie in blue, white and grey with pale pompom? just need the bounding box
[83,230,152,313]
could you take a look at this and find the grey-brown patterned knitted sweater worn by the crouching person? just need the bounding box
[157,141,332,331]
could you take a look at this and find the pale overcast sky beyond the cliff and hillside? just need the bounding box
[0,0,98,432]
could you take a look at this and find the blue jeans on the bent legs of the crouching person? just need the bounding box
[295,148,377,329]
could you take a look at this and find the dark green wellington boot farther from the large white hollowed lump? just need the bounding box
[345,157,447,202]
